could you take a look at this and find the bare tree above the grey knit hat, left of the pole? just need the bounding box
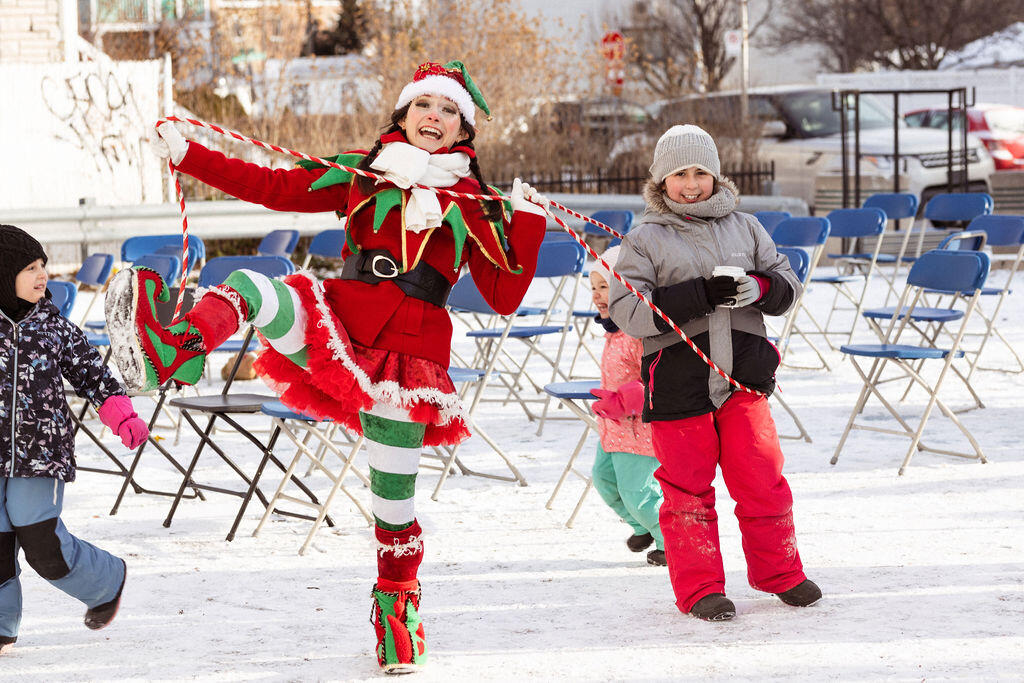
[620,0,774,97]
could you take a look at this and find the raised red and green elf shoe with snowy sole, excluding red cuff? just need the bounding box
[104,266,206,391]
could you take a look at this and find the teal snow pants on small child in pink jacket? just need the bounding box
[591,443,665,550]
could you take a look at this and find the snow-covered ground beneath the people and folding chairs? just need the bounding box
[0,254,1024,683]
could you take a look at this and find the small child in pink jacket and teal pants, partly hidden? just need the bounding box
[590,247,666,566]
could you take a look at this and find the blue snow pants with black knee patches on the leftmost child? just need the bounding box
[0,477,125,638]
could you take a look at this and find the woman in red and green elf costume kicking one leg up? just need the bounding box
[106,61,547,672]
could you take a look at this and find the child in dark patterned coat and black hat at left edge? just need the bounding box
[0,225,150,654]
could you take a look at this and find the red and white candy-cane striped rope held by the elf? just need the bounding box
[156,116,765,396]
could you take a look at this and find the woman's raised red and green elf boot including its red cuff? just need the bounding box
[104,266,246,391]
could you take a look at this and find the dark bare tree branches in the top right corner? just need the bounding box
[768,0,1024,72]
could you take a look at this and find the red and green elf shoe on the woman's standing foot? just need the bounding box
[371,579,427,674]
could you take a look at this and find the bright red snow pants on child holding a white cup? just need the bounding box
[650,391,806,612]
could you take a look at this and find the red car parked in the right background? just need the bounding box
[903,104,1024,171]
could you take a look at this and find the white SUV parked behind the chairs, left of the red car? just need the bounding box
[649,86,993,207]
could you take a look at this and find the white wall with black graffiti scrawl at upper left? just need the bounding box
[0,57,163,209]
